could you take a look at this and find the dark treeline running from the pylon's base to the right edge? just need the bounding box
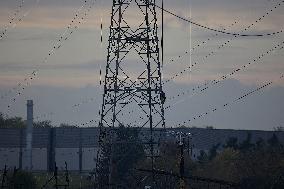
[96,126,284,189]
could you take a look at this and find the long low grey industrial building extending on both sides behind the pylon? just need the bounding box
[0,127,284,171]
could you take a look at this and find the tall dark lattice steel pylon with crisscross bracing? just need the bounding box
[98,0,165,188]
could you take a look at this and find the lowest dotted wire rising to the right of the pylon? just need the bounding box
[173,75,284,126]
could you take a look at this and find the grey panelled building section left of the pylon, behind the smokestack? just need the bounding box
[0,128,99,171]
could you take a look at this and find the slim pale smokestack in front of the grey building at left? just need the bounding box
[26,100,33,170]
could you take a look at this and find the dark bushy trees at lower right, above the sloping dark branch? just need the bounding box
[191,134,284,189]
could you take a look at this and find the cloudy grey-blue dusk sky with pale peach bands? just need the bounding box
[0,0,284,130]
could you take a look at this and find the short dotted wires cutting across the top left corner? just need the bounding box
[0,0,40,40]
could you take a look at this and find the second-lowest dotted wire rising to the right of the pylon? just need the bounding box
[165,41,284,104]
